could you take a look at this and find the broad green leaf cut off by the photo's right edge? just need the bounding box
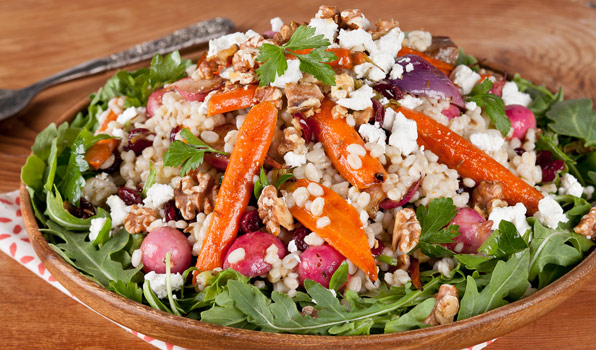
[546,98,596,147]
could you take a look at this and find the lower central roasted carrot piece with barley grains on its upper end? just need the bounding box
[282,179,377,281]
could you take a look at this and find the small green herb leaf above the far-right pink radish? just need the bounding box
[466,79,511,136]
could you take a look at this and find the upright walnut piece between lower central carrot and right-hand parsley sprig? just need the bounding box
[391,208,422,270]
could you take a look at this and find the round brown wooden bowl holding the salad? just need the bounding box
[20,100,596,350]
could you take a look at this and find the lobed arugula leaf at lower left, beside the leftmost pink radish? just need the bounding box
[43,221,142,287]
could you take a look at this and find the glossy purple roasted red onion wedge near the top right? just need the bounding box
[389,55,464,108]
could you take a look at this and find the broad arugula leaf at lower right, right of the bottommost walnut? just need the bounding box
[457,249,530,321]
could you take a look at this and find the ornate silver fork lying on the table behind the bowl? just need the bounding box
[0,17,234,120]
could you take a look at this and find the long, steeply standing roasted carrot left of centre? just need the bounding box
[197,101,277,271]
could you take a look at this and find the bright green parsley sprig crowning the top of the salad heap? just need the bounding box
[257,25,337,86]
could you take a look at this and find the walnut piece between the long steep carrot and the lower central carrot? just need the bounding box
[257,185,294,236]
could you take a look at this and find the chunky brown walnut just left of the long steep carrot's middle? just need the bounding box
[174,172,217,220]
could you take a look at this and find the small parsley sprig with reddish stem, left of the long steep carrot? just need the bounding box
[163,129,228,176]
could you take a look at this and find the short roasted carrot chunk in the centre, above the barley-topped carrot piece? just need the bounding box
[310,100,387,189]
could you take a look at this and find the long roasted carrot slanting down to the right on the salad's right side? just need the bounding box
[395,107,544,214]
